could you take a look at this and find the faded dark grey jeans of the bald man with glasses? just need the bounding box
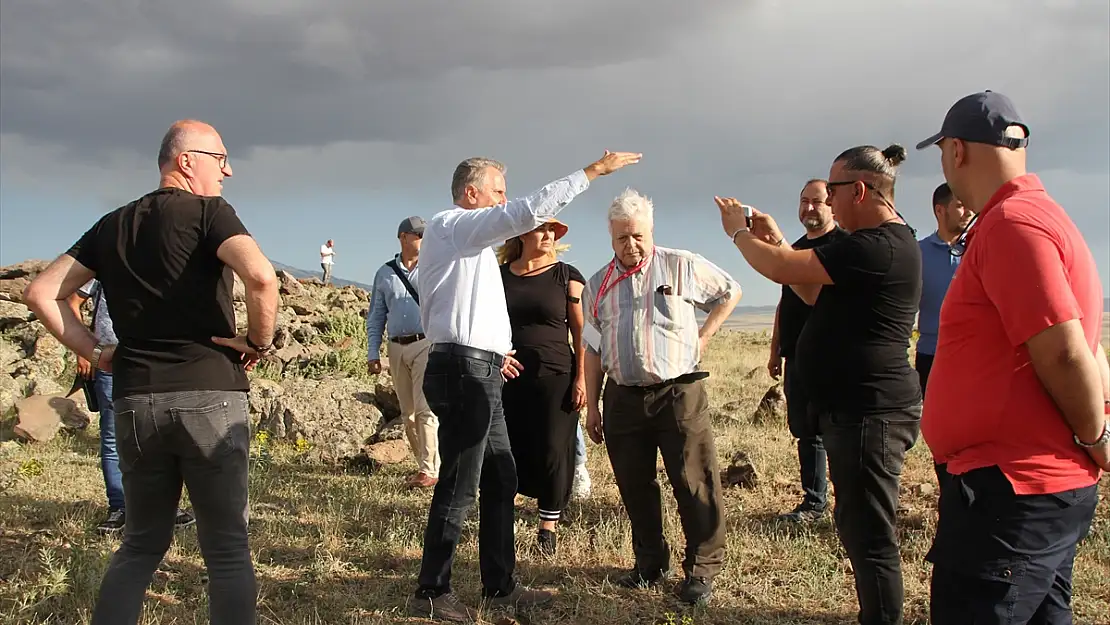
[92,391,256,625]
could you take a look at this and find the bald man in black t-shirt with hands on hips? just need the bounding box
[23,120,278,625]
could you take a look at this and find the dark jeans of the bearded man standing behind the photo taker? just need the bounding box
[783,357,828,511]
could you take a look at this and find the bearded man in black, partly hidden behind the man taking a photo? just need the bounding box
[767,179,848,523]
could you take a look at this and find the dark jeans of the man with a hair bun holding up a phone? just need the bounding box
[820,404,921,625]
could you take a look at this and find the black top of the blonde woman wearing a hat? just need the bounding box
[501,262,586,376]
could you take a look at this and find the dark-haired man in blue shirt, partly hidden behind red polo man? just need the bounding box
[914,182,975,397]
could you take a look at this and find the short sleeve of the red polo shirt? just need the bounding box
[981,220,1083,347]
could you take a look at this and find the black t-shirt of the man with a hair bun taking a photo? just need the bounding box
[796,222,921,415]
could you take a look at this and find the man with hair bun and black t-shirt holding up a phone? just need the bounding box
[717,145,921,625]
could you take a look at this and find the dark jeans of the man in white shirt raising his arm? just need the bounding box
[416,350,516,598]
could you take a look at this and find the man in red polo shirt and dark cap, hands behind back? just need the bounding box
[917,91,1110,625]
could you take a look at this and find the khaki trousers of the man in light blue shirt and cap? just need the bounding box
[389,339,440,477]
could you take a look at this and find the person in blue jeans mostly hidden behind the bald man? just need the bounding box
[68,279,196,534]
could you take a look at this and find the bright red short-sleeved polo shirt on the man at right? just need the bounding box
[921,174,1102,495]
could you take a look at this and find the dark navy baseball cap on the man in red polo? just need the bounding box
[917,89,1029,150]
